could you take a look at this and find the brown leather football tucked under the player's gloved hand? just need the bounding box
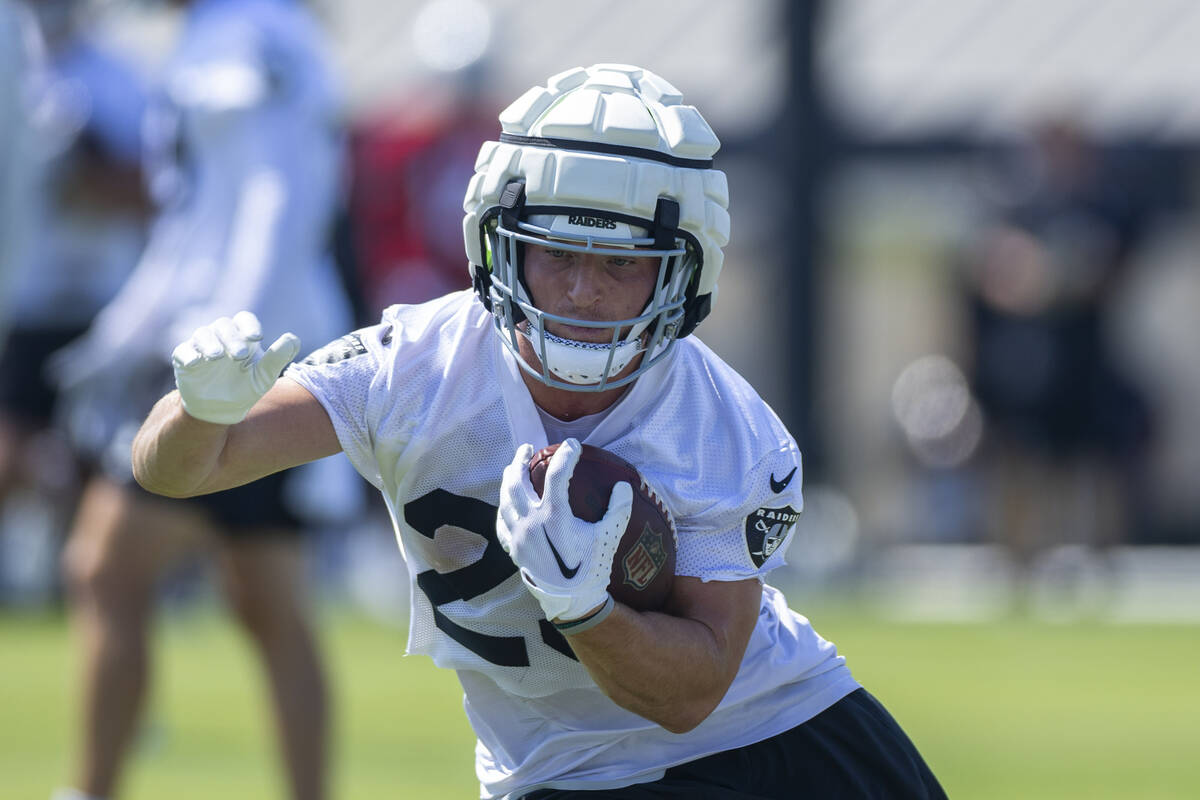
[529,444,676,610]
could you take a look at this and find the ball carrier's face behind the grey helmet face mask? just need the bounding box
[524,245,660,342]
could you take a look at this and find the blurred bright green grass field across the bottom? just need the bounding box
[0,612,1200,800]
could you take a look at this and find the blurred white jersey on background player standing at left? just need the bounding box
[79,0,352,363]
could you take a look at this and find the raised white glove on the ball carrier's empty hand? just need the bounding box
[170,311,300,425]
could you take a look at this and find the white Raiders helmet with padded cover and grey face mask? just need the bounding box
[463,64,730,391]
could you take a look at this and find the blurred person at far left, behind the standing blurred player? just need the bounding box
[0,0,148,599]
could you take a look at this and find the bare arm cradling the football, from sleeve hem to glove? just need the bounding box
[554,576,762,733]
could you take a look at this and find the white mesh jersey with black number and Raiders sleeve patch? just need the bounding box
[286,291,857,798]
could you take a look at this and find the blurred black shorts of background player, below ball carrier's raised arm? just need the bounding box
[128,470,301,541]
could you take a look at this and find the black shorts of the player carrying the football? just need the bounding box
[523,688,946,800]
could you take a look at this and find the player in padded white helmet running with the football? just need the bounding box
[126,65,944,798]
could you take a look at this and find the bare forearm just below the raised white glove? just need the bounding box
[133,391,229,498]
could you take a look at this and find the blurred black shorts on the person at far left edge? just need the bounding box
[0,326,86,427]
